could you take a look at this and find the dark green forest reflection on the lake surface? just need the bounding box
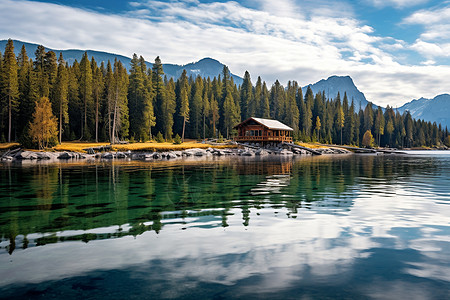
[0,155,439,254]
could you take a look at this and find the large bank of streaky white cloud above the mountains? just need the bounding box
[0,0,450,106]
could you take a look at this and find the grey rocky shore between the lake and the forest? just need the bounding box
[0,145,351,161]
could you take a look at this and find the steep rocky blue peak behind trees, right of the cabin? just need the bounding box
[302,76,369,111]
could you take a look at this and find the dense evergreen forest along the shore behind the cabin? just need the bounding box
[0,40,450,147]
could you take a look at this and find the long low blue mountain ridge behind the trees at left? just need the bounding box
[0,40,243,84]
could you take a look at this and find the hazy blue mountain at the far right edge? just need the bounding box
[398,94,450,128]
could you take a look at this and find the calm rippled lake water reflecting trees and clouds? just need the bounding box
[0,152,450,299]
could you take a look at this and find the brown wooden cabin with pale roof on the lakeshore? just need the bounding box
[234,117,294,144]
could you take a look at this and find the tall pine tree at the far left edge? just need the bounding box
[1,39,19,143]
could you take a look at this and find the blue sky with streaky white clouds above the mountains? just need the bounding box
[0,0,450,107]
